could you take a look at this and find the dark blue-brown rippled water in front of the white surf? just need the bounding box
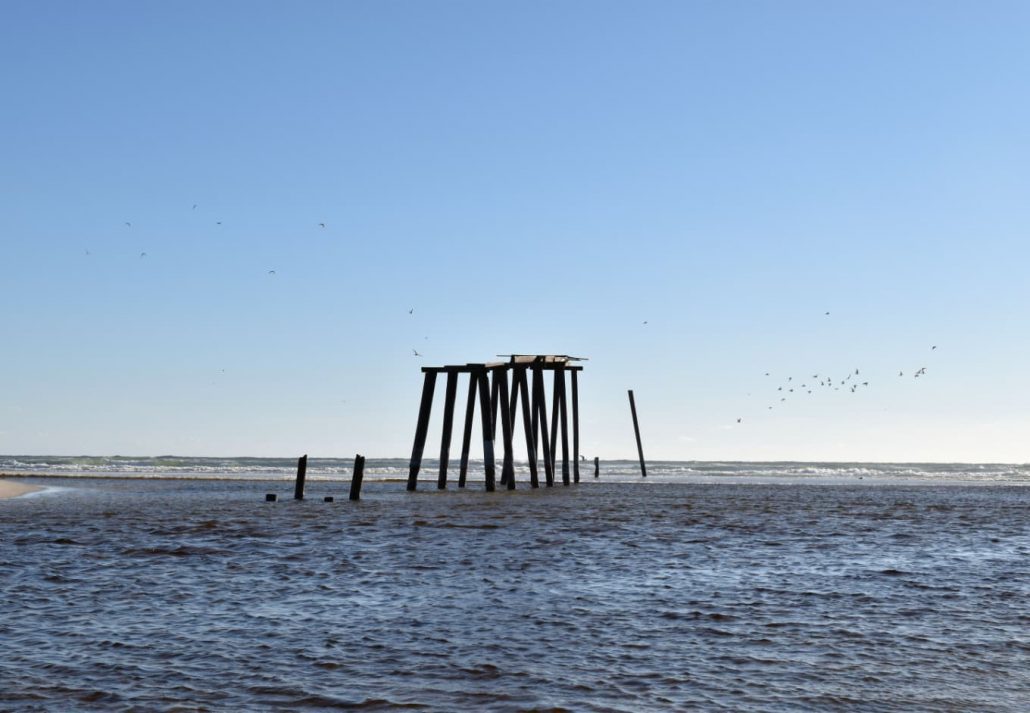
[0,477,1030,711]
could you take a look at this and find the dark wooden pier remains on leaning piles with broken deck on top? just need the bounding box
[408,354,584,491]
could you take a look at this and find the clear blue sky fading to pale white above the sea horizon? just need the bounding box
[0,0,1030,462]
